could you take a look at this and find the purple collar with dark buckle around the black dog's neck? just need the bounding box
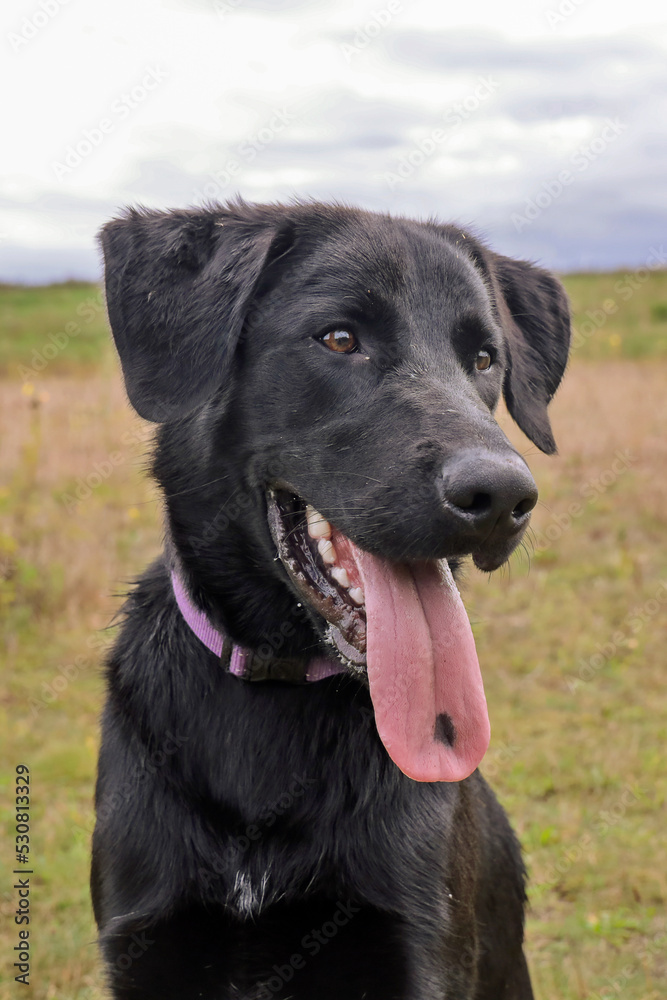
[171,569,345,684]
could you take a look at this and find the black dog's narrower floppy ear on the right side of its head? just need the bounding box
[485,252,570,455]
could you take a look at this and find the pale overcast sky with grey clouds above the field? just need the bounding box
[0,0,667,281]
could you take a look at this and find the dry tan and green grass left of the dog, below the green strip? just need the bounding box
[0,377,160,1000]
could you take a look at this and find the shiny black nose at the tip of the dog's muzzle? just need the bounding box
[442,448,537,538]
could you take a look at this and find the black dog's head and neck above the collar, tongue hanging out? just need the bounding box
[101,203,570,780]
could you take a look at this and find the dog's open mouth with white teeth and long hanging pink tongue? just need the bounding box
[267,489,490,781]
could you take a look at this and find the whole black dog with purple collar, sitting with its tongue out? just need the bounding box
[92,203,570,1000]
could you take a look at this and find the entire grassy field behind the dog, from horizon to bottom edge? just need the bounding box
[0,272,667,1000]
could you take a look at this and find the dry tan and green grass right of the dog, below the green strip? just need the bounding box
[466,362,667,1000]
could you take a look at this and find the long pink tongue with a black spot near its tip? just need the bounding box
[334,533,490,781]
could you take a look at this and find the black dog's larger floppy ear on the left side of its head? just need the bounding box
[100,203,282,422]
